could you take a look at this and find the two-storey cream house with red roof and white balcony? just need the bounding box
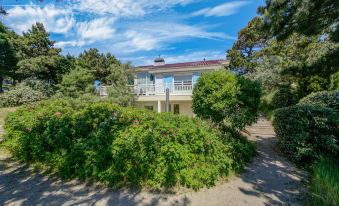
[131,57,228,116]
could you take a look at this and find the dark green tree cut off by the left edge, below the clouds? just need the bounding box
[0,23,17,93]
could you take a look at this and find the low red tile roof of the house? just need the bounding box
[136,59,225,69]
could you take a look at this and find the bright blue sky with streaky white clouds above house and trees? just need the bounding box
[0,0,264,66]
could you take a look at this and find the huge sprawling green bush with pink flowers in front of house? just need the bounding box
[0,100,253,189]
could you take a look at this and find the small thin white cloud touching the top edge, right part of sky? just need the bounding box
[192,1,250,17]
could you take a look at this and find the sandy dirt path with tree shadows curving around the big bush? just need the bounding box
[0,120,305,206]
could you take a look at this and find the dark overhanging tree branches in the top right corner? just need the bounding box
[258,0,339,42]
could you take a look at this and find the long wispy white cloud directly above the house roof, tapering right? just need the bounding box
[115,22,235,52]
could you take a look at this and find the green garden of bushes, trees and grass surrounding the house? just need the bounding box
[0,0,339,205]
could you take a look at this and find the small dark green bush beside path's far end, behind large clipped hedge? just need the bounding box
[271,86,297,109]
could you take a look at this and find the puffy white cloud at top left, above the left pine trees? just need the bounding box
[5,5,75,34]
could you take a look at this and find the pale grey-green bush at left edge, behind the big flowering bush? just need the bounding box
[0,85,46,107]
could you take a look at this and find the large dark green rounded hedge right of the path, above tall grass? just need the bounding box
[273,105,339,165]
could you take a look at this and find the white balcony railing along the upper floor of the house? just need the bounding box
[100,83,194,96]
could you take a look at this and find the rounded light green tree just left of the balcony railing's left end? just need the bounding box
[57,67,95,98]
